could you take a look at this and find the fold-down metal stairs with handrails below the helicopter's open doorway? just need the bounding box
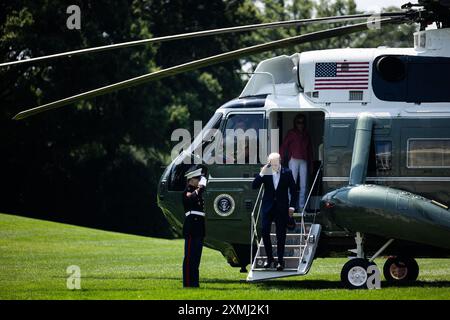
[247,165,321,281]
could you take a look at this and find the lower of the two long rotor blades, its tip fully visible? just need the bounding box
[13,17,405,120]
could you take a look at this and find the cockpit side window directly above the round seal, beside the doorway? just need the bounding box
[224,114,264,164]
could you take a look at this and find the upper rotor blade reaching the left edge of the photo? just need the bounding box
[0,12,405,67]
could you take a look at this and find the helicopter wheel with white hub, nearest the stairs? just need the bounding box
[341,258,375,289]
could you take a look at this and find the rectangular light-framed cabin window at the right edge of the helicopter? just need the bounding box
[407,139,450,168]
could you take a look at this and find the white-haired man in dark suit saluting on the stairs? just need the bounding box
[253,153,298,271]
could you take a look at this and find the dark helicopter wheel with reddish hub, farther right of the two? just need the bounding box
[383,256,419,284]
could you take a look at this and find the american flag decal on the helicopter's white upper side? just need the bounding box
[314,62,369,90]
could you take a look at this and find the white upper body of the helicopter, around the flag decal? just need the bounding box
[240,28,450,116]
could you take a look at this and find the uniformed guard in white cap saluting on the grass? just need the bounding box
[183,168,207,287]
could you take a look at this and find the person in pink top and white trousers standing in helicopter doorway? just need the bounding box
[280,113,312,211]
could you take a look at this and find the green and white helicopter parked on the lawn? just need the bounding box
[5,0,450,288]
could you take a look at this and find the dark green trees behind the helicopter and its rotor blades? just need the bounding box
[0,0,414,237]
